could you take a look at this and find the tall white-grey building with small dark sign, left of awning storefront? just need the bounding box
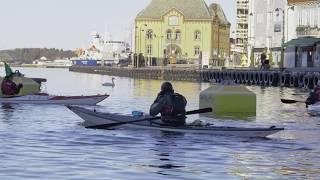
[248,0,286,66]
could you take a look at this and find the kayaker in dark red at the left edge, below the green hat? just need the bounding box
[1,75,23,96]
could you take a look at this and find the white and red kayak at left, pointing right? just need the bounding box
[0,93,109,105]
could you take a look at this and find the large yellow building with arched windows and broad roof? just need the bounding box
[135,0,230,66]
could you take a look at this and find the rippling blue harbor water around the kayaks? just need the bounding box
[0,68,320,179]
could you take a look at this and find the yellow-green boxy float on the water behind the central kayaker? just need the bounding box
[199,85,256,119]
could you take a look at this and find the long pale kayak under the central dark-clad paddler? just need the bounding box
[67,106,284,137]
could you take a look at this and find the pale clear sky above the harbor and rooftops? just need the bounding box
[0,0,236,50]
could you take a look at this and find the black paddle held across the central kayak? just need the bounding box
[86,108,212,129]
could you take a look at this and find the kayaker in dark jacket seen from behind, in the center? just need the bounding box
[149,82,187,126]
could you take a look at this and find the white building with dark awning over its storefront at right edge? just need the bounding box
[284,0,320,68]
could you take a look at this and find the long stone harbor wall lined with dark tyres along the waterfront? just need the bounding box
[69,66,320,89]
